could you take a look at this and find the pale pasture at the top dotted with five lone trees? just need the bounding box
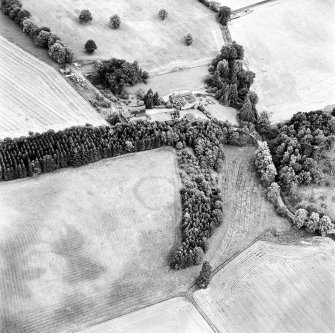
[23,0,223,72]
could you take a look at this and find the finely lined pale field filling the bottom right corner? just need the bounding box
[194,237,335,333]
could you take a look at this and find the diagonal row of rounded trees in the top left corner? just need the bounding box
[1,0,73,64]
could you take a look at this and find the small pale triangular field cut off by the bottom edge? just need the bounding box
[82,297,213,333]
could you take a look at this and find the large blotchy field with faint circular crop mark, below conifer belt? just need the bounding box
[0,149,199,333]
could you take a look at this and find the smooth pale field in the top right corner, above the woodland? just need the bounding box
[229,0,335,122]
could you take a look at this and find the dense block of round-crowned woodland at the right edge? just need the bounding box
[269,111,335,193]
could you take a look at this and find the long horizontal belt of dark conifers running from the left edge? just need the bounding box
[0,119,252,180]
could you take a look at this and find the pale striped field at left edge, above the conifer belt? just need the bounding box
[0,36,106,138]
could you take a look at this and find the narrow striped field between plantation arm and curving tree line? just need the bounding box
[206,146,290,267]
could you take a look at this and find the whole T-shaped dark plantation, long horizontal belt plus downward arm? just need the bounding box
[0,119,250,269]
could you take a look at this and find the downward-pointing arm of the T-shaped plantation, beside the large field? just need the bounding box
[170,147,224,269]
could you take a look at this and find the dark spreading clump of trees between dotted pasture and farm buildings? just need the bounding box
[90,58,149,95]
